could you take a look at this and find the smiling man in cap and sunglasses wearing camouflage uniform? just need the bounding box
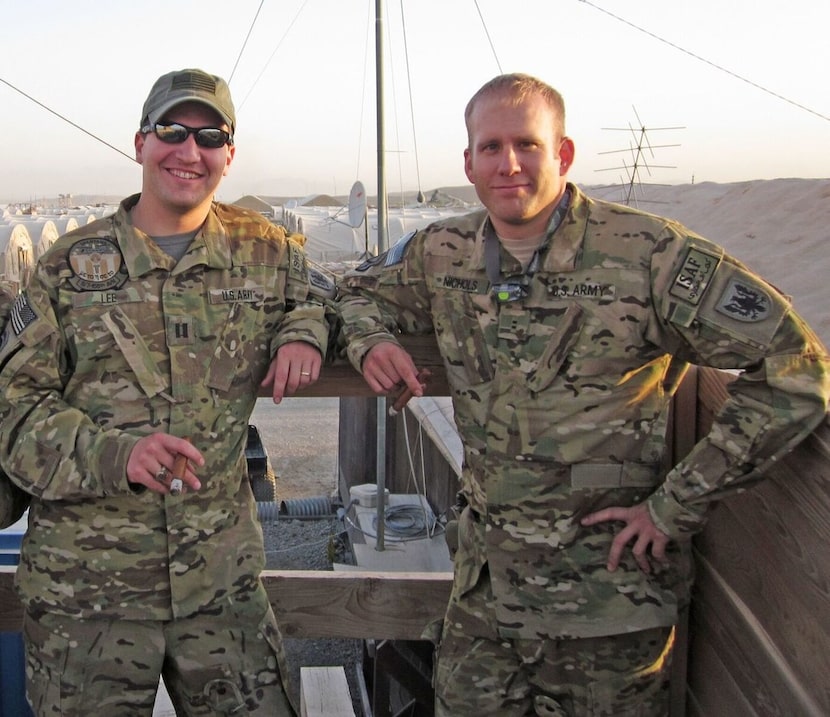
[0,70,328,717]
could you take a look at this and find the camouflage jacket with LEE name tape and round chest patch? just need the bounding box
[0,197,327,620]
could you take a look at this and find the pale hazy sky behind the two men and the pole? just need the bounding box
[0,0,830,202]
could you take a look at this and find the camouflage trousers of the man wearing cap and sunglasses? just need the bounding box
[23,589,295,717]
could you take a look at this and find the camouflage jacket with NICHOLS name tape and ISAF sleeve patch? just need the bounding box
[339,185,830,638]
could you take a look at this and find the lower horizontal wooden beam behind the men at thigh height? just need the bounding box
[0,565,452,640]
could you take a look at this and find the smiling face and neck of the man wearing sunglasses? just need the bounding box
[133,102,235,235]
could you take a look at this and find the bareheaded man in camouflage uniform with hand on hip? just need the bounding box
[339,75,830,717]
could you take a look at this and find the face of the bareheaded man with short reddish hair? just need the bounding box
[464,92,574,239]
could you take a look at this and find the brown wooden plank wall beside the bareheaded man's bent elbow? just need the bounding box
[686,369,830,717]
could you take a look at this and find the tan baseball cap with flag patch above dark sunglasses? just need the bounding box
[140,69,236,134]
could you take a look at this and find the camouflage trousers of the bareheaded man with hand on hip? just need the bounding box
[434,570,674,717]
